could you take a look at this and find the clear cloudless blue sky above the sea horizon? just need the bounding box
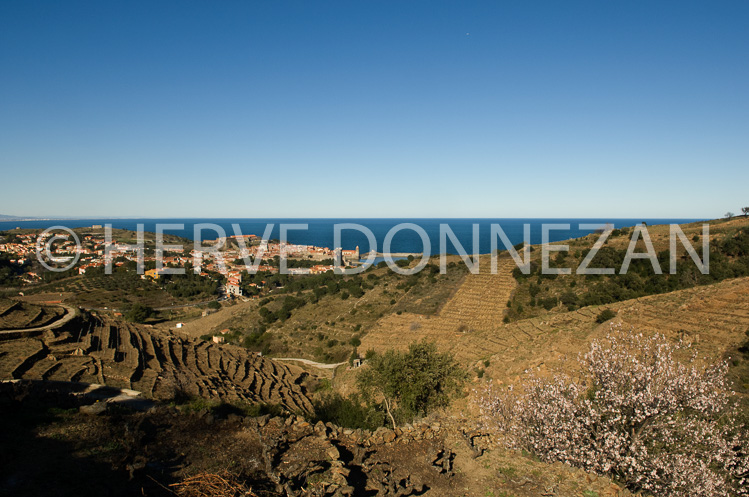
[0,0,749,218]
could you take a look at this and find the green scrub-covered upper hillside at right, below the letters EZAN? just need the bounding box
[507,218,749,321]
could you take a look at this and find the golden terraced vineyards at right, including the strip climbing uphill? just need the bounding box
[360,254,749,381]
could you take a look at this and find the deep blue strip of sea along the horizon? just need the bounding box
[0,218,699,255]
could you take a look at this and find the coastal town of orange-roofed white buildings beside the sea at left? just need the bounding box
[0,225,360,296]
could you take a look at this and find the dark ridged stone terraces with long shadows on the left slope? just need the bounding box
[0,318,312,412]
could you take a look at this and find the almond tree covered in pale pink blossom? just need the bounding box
[480,325,749,497]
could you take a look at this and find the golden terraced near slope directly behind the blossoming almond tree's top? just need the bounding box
[456,278,749,381]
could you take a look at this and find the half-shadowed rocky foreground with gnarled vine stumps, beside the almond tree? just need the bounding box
[0,382,629,497]
